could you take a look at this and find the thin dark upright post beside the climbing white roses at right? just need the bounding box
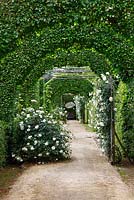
[109,77,115,165]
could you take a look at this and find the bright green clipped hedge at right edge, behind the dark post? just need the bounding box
[116,79,134,159]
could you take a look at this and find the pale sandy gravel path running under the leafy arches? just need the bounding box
[1,121,134,200]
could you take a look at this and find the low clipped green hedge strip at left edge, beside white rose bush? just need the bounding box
[0,121,7,167]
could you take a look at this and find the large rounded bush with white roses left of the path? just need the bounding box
[12,107,71,163]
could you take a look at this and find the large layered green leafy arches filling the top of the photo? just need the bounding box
[0,0,134,165]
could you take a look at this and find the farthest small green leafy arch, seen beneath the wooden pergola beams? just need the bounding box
[44,75,93,110]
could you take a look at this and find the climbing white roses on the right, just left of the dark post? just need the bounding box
[88,72,114,156]
